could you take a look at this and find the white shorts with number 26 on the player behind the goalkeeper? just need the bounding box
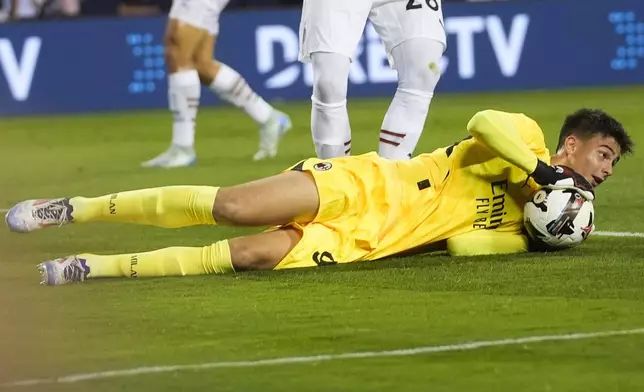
[299,0,447,66]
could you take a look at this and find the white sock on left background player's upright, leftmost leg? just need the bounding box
[168,69,201,148]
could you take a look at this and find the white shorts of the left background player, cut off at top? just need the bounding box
[170,0,230,35]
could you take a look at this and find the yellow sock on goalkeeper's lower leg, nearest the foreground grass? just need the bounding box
[77,240,235,278]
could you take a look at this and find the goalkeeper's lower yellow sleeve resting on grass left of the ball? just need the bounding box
[447,230,529,256]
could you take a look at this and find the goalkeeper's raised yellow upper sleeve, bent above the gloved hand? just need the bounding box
[467,110,548,174]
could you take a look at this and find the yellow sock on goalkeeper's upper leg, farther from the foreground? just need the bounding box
[69,186,219,228]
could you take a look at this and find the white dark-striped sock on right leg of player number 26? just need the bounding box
[378,88,432,160]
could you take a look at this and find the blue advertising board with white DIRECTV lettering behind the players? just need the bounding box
[0,0,644,115]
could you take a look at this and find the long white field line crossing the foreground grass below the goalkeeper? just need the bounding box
[5,328,644,387]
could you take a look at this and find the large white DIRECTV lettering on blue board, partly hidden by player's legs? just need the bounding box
[255,14,530,89]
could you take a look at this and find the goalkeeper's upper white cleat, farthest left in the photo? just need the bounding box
[5,199,72,233]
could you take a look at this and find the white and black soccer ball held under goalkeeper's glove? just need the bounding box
[523,188,595,250]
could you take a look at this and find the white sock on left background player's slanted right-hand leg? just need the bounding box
[209,63,273,124]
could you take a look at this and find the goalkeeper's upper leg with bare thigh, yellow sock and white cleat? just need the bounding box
[6,171,320,232]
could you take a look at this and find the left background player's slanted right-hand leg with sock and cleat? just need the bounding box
[195,35,291,160]
